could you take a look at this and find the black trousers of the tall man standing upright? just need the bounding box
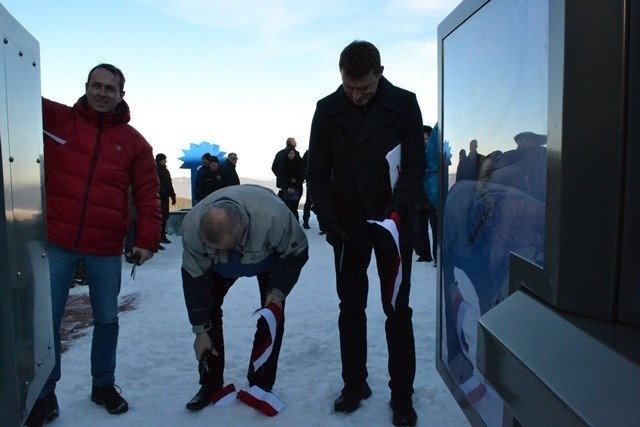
[334,224,416,396]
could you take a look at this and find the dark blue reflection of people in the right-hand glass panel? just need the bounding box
[442,132,546,403]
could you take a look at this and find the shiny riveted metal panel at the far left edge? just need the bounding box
[0,5,55,426]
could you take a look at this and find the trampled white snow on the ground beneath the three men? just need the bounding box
[51,218,468,427]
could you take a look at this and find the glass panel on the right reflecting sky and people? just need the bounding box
[441,0,548,425]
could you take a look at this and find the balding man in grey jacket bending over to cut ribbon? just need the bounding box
[181,185,309,415]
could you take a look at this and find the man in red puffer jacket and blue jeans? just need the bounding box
[27,64,162,425]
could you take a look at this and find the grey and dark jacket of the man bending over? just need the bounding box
[182,185,309,331]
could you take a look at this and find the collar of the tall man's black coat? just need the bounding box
[328,76,401,144]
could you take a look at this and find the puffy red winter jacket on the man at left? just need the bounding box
[42,96,162,255]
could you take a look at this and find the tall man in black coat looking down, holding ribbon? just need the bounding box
[307,41,425,425]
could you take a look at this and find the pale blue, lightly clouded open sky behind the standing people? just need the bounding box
[0,0,459,179]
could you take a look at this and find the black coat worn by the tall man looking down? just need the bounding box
[307,77,425,232]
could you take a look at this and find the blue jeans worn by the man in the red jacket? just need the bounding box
[40,244,122,397]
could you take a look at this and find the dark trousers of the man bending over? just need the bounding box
[200,272,284,390]
